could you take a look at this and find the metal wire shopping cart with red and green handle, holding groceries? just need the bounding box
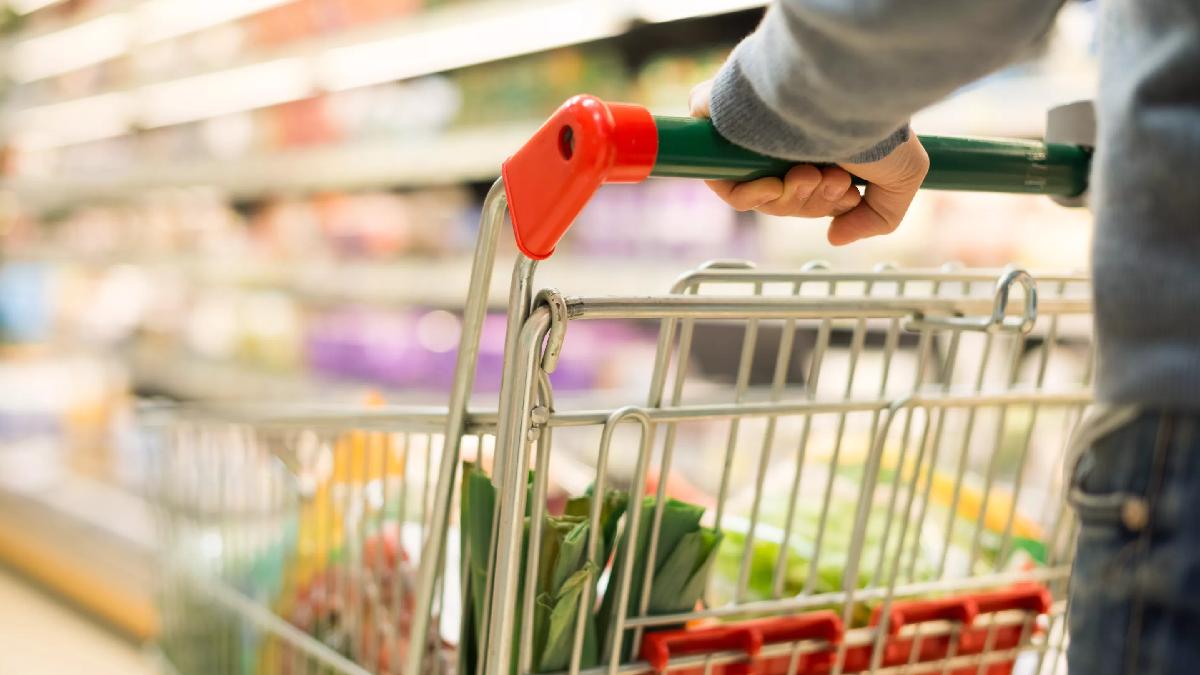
[156,96,1092,675]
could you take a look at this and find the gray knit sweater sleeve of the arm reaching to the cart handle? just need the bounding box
[712,0,1061,161]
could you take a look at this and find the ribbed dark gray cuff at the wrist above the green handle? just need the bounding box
[709,53,911,162]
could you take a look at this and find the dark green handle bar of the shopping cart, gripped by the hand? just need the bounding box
[650,117,1091,197]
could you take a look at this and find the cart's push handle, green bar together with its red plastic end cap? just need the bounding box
[502,95,1091,259]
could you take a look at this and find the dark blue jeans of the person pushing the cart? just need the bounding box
[1067,412,1200,675]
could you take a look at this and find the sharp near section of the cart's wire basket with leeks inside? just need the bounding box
[474,263,1092,673]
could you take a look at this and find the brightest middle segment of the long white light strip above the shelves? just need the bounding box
[317,1,623,90]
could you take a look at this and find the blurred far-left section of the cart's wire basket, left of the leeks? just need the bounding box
[157,410,491,674]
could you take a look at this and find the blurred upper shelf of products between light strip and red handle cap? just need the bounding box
[8,46,652,201]
